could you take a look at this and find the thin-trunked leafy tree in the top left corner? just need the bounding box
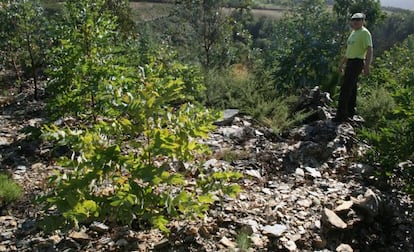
[0,0,48,98]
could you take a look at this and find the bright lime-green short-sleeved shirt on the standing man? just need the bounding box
[345,27,372,59]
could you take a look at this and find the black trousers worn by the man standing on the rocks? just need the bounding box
[336,59,364,121]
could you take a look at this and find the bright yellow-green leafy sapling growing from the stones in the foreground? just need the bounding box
[41,62,243,228]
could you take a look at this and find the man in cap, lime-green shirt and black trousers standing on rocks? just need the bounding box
[334,13,373,122]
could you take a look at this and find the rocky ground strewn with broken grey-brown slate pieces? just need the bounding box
[0,88,414,251]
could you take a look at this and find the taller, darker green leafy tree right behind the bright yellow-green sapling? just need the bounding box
[48,0,203,119]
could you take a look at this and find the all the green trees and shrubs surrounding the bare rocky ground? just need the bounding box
[0,0,414,251]
